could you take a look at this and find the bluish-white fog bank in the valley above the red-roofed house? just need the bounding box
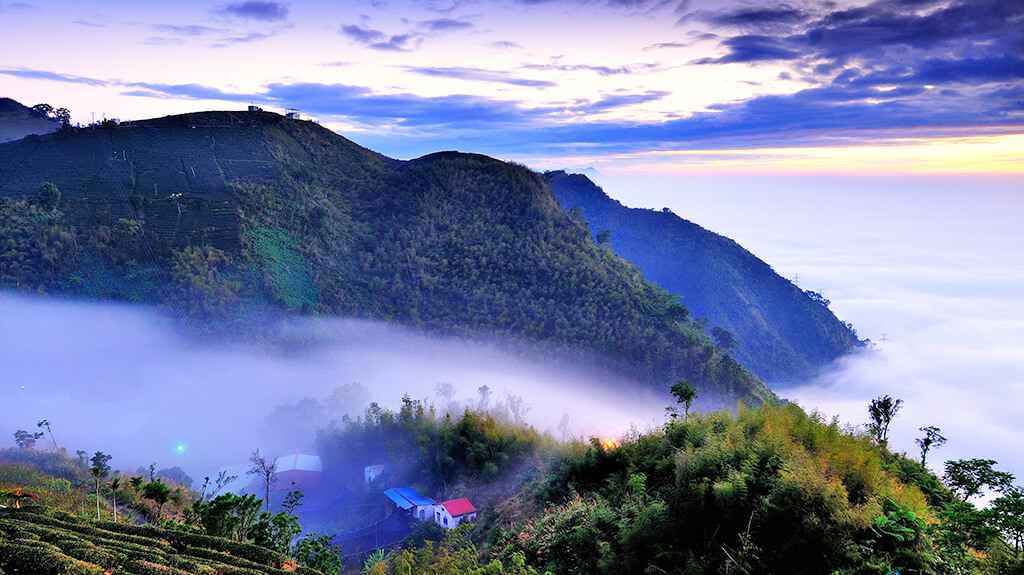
[0,293,665,479]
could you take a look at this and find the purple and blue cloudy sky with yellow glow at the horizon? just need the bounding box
[0,0,1024,173]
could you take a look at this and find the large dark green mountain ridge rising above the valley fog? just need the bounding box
[0,113,770,405]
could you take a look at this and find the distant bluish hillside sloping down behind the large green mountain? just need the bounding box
[545,172,861,383]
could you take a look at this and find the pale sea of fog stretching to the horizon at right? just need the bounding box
[598,173,1024,485]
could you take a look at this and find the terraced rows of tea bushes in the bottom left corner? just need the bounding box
[0,508,318,575]
